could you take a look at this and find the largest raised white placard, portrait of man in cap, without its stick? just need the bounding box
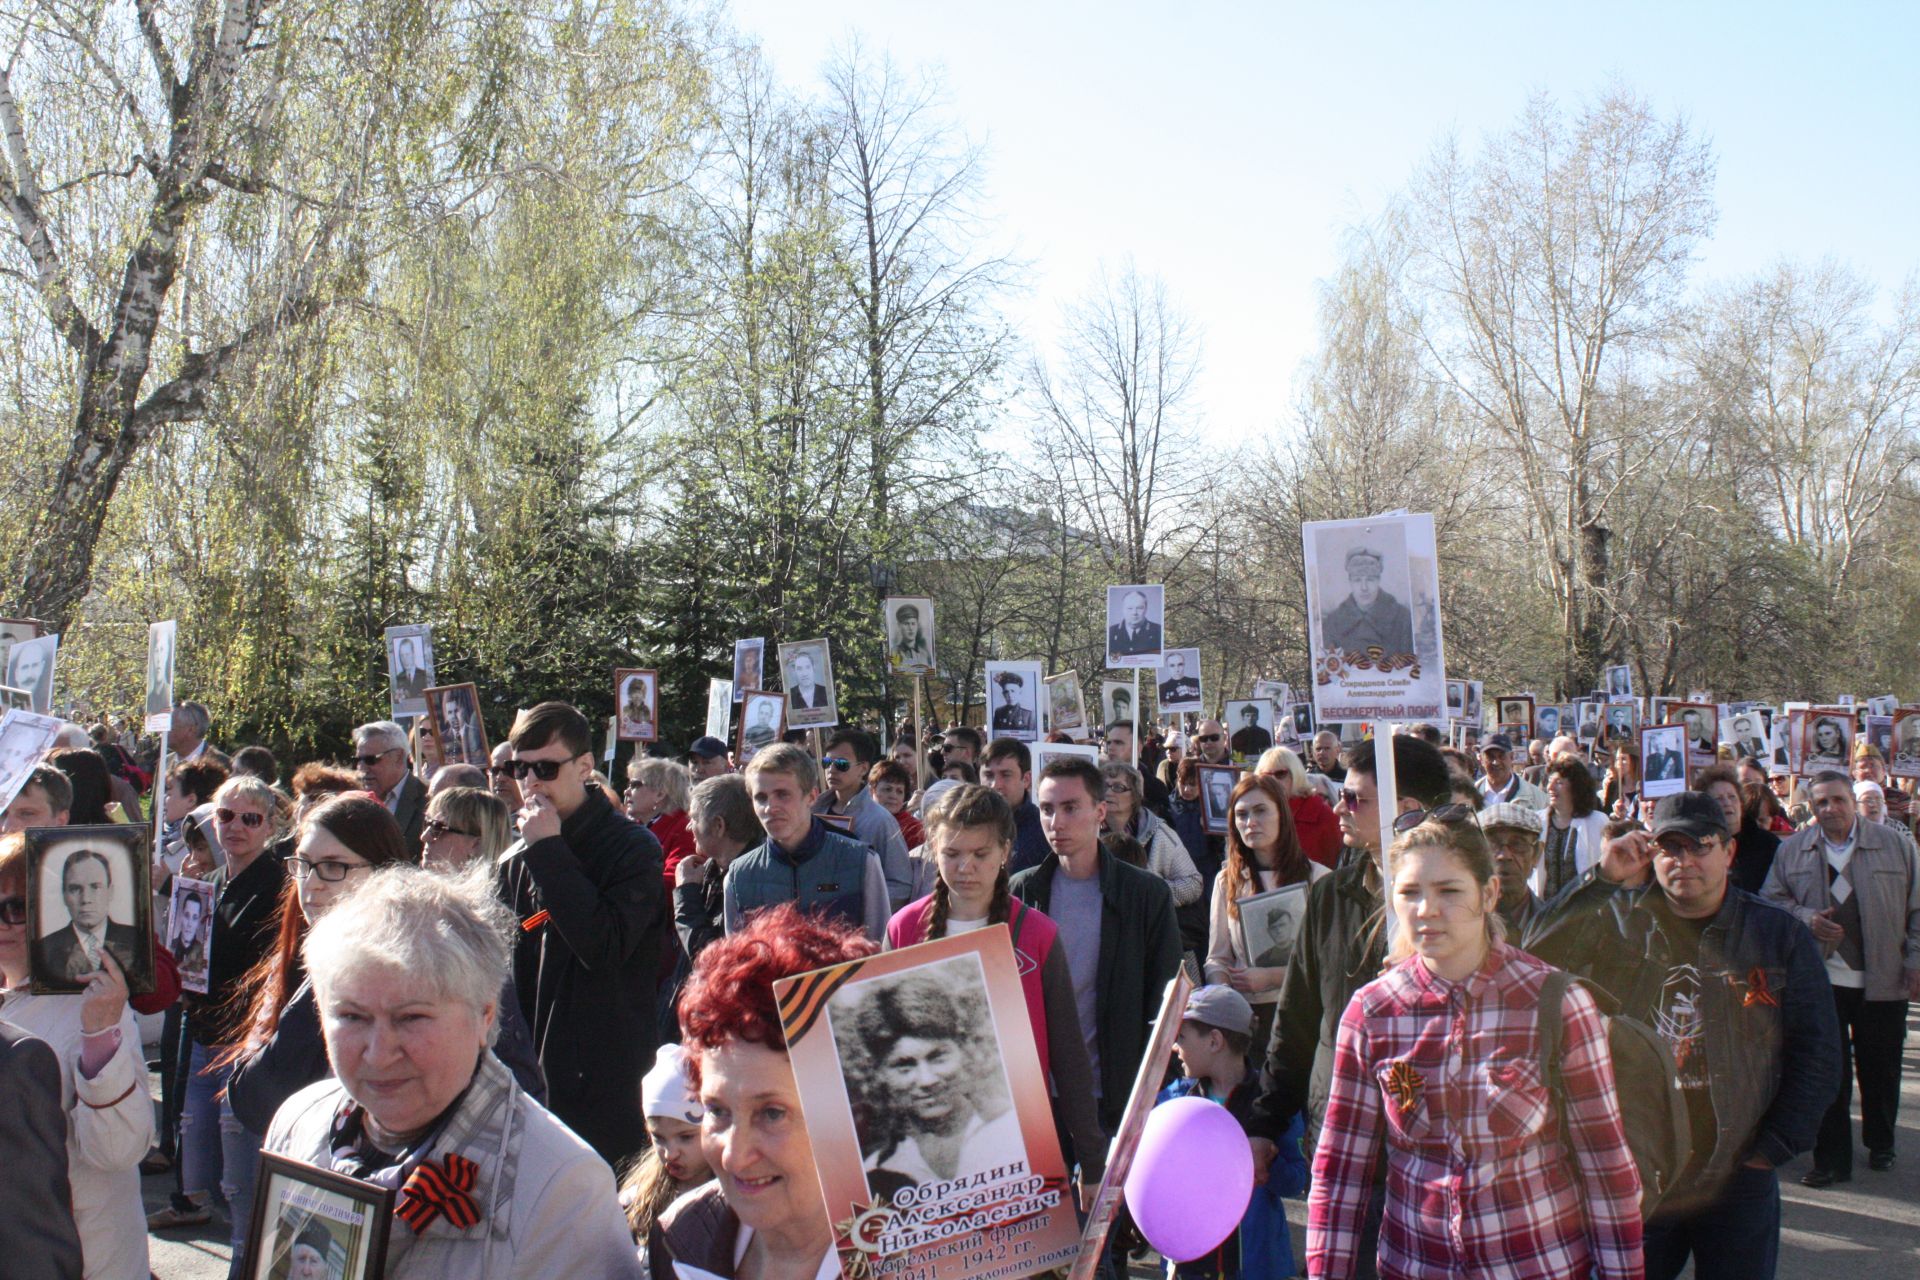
[1300,514,1446,723]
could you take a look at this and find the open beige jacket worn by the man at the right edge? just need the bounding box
[1761,818,1920,1000]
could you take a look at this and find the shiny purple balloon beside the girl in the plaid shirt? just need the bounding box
[1125,1098,1254,1263]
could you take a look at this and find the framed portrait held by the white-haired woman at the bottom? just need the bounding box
[242,1151,394,1280]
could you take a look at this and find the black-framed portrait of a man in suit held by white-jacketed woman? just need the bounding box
[27,823,154,994]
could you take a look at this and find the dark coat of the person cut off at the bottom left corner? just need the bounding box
[0,1021,81,1280]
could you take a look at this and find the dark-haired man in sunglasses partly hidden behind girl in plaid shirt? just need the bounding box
[1246,735,1473,1280]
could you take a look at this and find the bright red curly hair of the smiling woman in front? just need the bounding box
[680,902,879,1065]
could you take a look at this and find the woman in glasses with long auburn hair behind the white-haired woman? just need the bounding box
[230,791,545,1140]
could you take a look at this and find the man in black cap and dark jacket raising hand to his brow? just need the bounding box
[1524,791,1839,1280]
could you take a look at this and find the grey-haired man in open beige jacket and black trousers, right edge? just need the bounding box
[1761,770,1920,1188]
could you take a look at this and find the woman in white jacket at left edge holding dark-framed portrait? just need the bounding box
[0,835,154,1280]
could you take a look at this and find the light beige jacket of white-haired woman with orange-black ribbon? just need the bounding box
[265,1052,641,1280]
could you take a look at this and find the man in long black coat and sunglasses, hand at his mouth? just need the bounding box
[499,702,666,1167]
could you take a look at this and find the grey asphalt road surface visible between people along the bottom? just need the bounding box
[146,1009,1920,1280]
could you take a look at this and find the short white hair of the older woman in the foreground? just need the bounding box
[300,862,515,1046]
